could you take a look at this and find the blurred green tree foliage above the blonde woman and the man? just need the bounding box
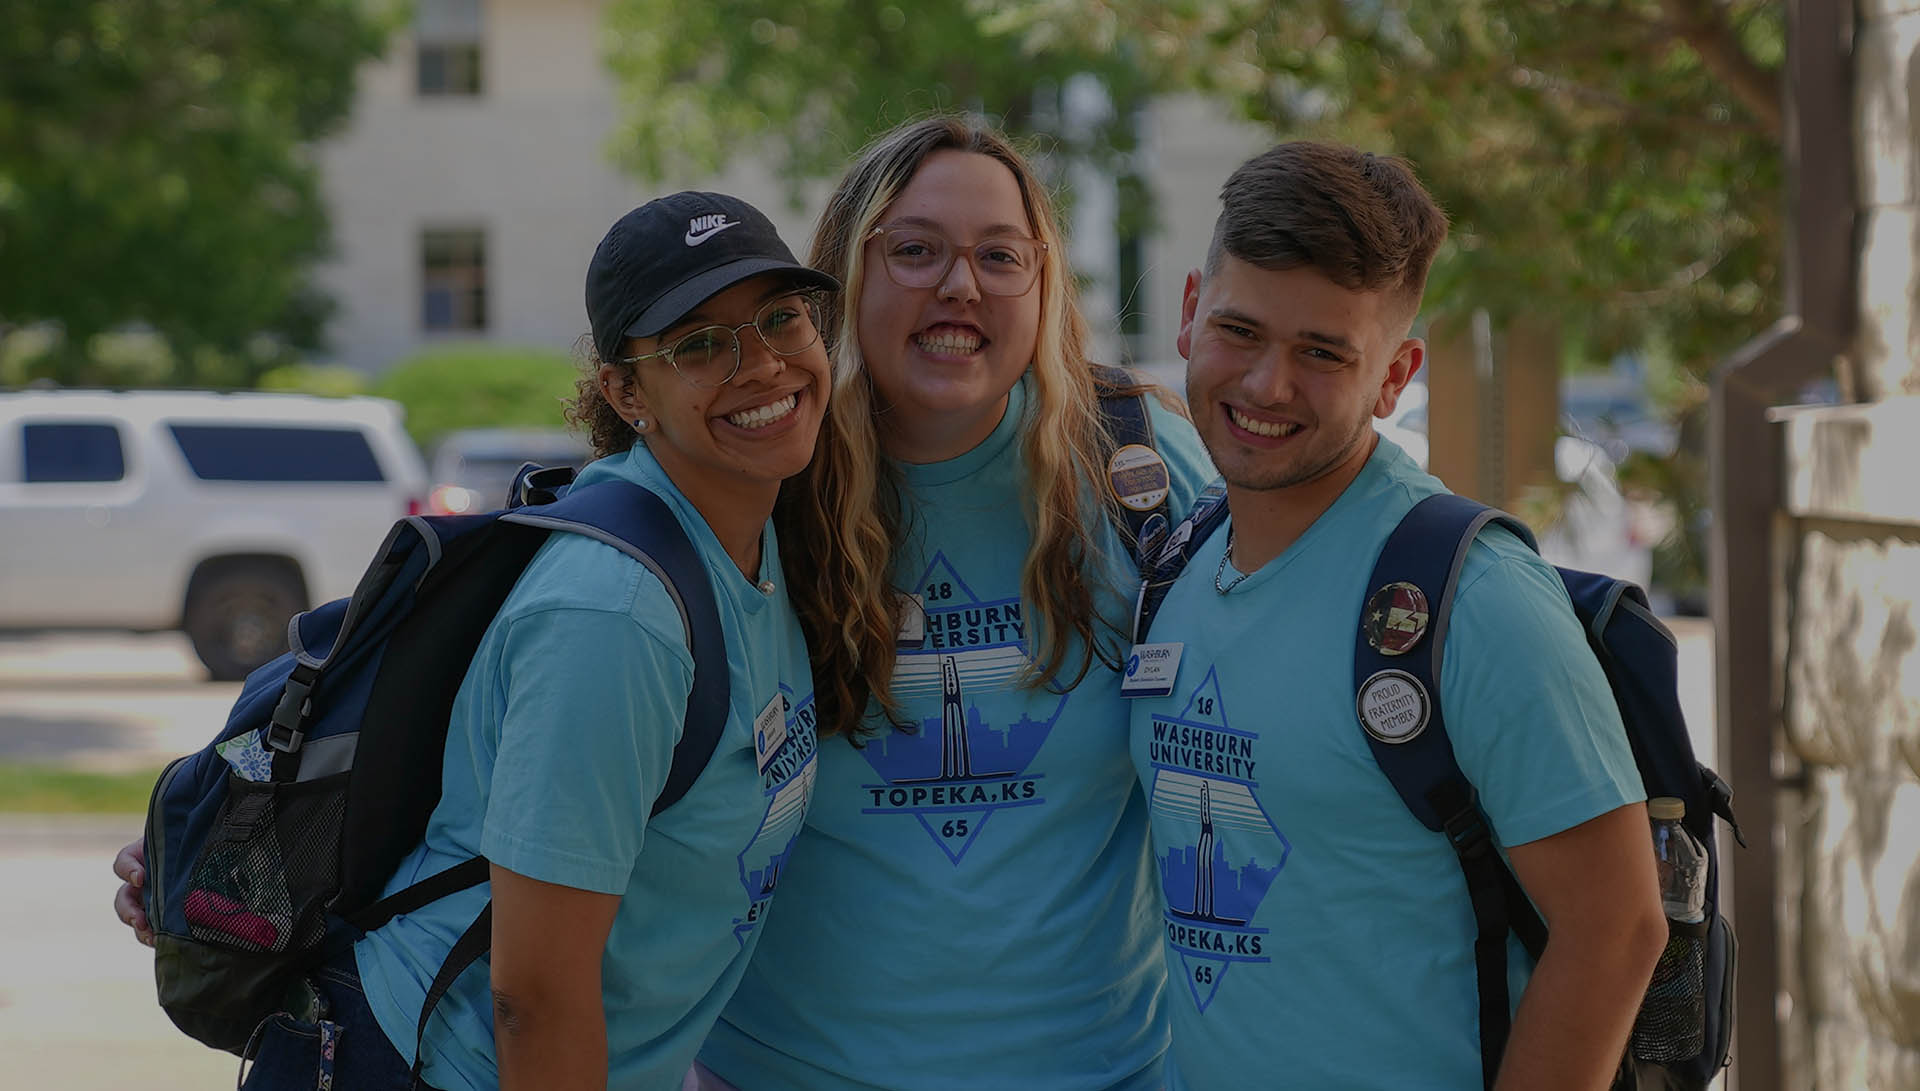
[609,0,1784,369]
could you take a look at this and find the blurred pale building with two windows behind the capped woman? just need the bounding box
[317,0,810,371]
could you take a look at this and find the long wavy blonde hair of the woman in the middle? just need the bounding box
[776,115,1140,730]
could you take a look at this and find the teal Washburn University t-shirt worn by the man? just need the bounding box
[1133,440,1644,1091]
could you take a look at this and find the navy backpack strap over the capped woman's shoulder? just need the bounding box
[501,480,730,814]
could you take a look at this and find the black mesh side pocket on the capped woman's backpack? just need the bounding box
[182,772,349,953]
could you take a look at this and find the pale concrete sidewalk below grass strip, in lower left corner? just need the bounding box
[0,814,240,1091]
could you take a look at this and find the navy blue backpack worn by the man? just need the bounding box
[1135,486,1745,1091]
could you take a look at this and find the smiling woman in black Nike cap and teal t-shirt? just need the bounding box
[121,192,837,1091]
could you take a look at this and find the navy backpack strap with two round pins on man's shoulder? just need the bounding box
[1354,494,1546,1087]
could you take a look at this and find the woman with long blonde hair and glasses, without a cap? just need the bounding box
[701,117,1213,1091]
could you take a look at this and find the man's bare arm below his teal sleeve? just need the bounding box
[1496,803,1667,1091]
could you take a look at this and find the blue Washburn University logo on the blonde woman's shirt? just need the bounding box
[860,553,1068,866]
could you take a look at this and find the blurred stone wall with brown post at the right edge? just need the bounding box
[1713,0,1920,1091]
